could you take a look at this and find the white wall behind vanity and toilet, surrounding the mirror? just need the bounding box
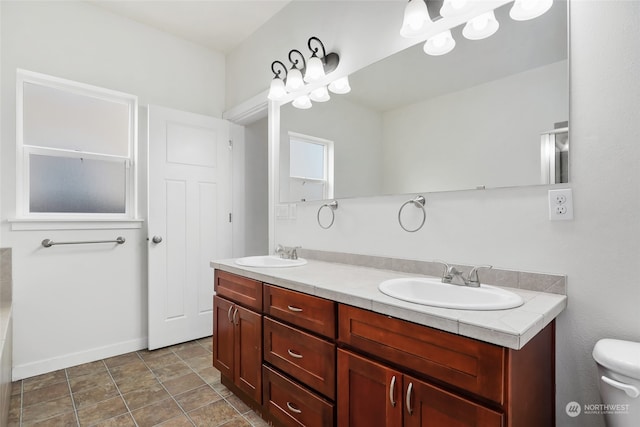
[236,0,640,426]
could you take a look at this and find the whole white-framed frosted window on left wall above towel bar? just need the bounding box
[17,70,137,220]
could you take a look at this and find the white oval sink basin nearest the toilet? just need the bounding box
[378,278,524,310]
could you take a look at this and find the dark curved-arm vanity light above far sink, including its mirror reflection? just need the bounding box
[267,36,350,109]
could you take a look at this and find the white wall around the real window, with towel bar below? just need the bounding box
[0,1,225,379]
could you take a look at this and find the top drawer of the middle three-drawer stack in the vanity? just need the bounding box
[264,284,336,339]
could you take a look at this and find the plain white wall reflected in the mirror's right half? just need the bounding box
[380,61,569,194]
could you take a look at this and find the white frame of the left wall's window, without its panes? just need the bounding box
[16,69,138,221]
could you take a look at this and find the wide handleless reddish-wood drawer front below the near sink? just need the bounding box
[338,304,505,404]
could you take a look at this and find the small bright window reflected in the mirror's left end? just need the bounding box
[289,132,333,201]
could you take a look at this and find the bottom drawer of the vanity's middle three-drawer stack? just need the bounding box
[262,365,335,427]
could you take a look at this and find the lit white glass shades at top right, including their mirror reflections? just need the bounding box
[402,0,553,56]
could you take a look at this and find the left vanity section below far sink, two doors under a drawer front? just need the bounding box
[213,270,262,407]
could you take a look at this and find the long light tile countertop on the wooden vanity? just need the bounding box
[210,259,567,350]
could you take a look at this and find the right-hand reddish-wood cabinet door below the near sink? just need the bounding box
[404,376,503,427]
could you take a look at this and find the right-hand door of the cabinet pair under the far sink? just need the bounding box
[232,305,262,404]
